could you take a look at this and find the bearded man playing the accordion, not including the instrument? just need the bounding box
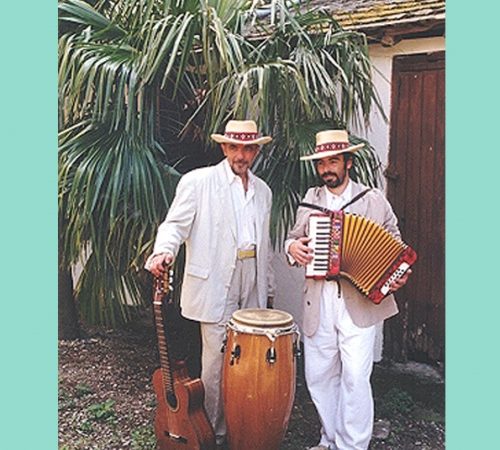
[285,130,411,450]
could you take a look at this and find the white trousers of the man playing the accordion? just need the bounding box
[304,282,375,450]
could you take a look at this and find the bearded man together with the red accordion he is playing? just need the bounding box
[285,130,416,450]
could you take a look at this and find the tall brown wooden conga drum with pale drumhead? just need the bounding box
[222,309,299,450]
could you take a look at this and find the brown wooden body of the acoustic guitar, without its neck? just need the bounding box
[153,358,215,450]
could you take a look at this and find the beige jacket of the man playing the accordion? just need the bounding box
[287,182,400,336]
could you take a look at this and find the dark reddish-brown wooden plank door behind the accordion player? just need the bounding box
[385,52,445,361]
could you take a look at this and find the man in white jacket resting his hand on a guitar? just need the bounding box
[146,120,274,445]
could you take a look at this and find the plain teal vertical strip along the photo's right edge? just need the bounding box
[446,1,500,450]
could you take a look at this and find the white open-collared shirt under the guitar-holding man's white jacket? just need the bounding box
[224,159,257,250]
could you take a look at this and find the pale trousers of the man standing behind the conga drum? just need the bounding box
[200,258,258,443]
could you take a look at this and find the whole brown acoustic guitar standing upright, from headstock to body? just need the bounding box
[153,270,215,450]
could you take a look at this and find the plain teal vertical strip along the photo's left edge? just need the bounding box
[0,1,57,450]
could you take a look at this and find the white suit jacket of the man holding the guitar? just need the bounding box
[146,162,274,322]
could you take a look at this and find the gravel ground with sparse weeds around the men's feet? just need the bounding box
[59,316,445,450]
